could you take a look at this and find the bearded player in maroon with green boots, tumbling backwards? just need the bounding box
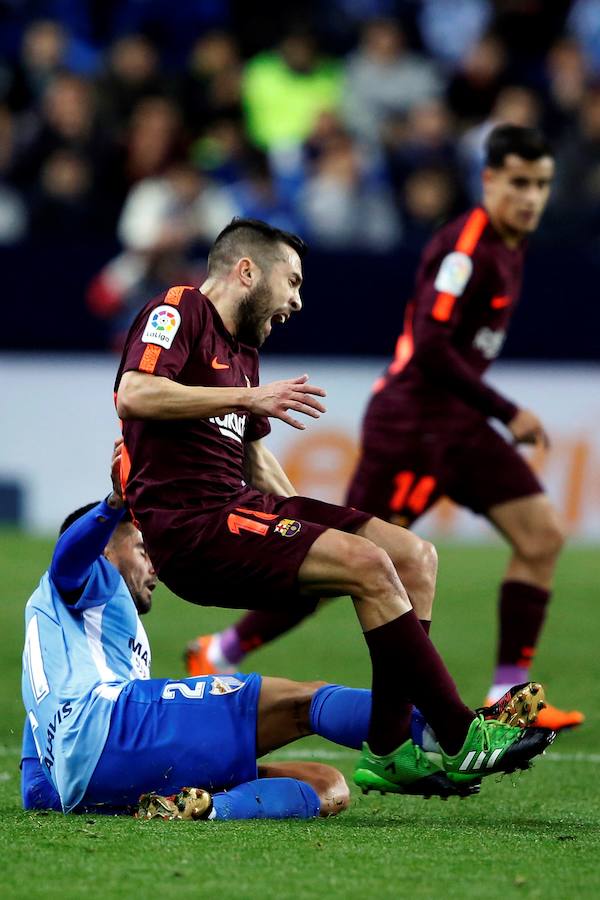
[115,219,554,794]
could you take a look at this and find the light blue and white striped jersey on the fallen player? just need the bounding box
[22,556,150,812]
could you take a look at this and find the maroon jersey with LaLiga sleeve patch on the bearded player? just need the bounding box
[115,287,270,569]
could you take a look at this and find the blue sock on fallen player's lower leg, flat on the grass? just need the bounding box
[213,778,321,820]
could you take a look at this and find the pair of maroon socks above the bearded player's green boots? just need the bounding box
[365,610,473,755]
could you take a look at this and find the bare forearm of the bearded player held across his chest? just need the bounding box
[117,372,250,419]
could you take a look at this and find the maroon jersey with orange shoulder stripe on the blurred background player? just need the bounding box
[367,207,524,431]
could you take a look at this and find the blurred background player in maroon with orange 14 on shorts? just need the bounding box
[187,126,583,729]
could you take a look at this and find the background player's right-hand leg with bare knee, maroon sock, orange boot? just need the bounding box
[488,493,584,730]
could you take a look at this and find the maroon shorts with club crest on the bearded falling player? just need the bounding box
[157,488,372,609]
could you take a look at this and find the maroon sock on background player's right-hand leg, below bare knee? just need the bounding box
[498,581,550,669]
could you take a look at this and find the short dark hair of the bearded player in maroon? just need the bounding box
[208,217,308,275]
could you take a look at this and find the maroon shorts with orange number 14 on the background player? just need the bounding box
[346,421,544,525]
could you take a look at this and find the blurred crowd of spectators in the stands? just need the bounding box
[0,0,600,344]
